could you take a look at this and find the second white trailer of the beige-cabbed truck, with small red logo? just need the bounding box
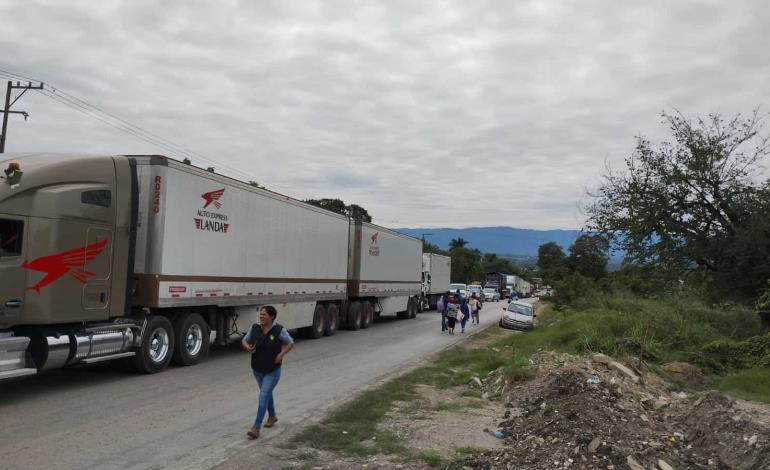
[346,220,422,329]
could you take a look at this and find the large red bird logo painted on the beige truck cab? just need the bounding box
[21,240,107,294]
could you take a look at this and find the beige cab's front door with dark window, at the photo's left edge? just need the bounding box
[0,218,28,328]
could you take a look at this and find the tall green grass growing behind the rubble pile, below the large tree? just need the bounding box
[496,293,759,365]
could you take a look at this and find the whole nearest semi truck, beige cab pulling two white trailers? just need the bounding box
[0,154,422,379]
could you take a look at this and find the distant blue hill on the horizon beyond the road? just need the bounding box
[396,227,580,256]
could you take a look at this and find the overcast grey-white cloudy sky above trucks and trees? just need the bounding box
[0,0,770,228]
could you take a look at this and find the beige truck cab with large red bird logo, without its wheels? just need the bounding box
[0,154,132,376]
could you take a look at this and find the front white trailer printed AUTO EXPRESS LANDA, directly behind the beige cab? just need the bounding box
[134,158,349,344]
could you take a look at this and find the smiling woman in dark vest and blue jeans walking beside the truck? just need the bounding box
[241,305,294,439]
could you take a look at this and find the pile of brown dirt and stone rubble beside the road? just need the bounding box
[450,353,770,470]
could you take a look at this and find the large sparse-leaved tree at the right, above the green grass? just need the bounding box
[587,111,770,295]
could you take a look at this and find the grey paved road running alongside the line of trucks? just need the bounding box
[0,302,520,469]
